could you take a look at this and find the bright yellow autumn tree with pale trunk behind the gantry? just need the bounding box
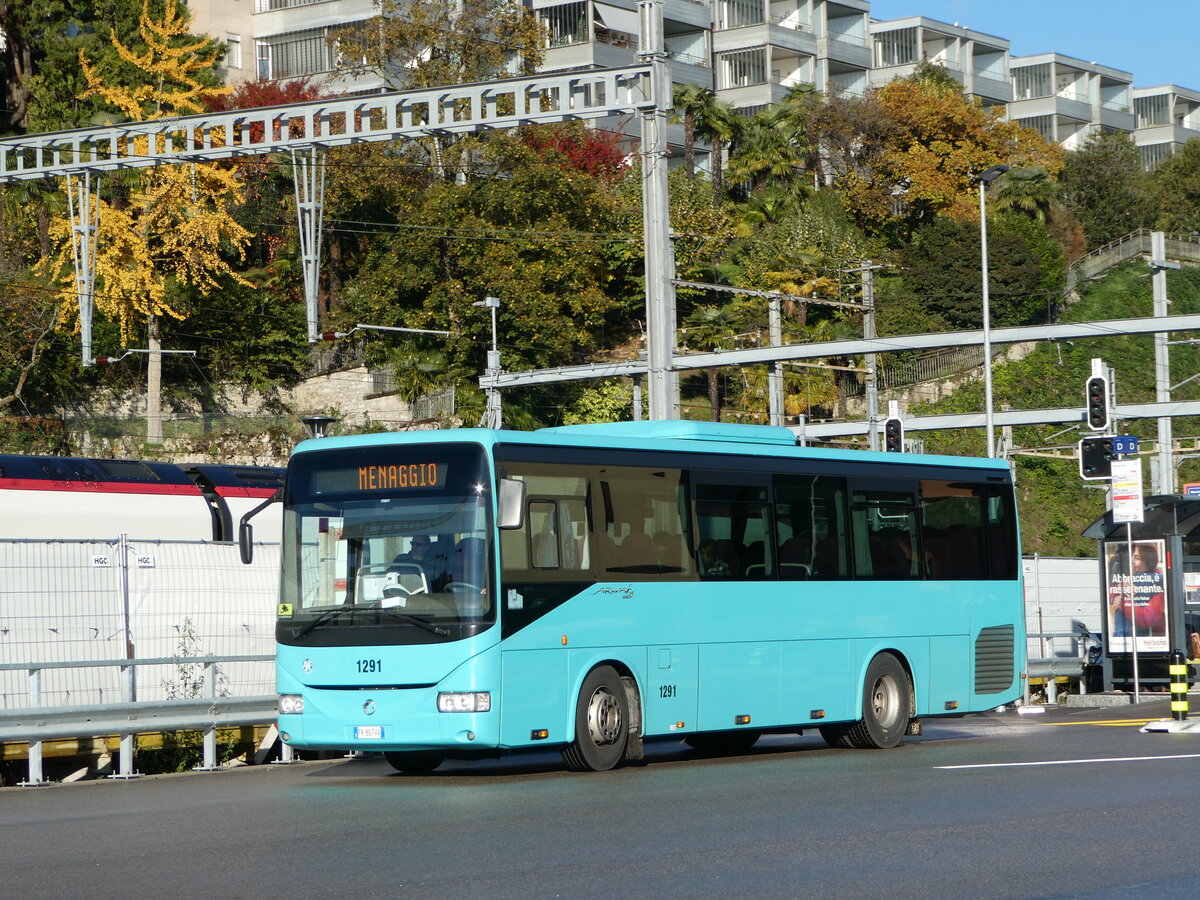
[58,1,251,443]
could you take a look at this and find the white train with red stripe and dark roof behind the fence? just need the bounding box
[0,454,283,541]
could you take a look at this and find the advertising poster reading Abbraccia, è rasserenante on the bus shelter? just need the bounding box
[1104,540,1170,653]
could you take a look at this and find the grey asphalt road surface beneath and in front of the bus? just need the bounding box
[0,701,1200,899]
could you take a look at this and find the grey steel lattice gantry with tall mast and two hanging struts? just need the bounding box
[0,0,674,408]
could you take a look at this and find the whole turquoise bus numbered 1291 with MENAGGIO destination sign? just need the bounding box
[253,421,1025,772]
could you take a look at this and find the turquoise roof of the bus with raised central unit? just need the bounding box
[294,420,1008,472]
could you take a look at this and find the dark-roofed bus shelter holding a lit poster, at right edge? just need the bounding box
[1084,494,1200,690]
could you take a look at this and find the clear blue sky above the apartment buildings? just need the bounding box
[871,0,1200,90]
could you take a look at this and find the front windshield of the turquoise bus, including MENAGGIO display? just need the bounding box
[277,444,496,646]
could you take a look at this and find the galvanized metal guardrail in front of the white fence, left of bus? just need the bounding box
[0,655,277,786]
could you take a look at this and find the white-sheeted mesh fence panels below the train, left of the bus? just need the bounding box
[0,540,278,709]
